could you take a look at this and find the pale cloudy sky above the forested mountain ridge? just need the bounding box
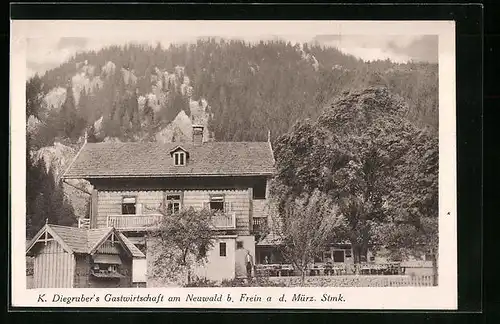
[26,34,438,78]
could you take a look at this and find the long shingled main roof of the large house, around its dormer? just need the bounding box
[64,142,274,179]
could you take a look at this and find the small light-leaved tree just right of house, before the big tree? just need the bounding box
[272,187,342,285]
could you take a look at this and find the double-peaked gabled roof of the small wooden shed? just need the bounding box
[26,224,146,258]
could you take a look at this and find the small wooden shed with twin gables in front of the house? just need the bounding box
[26,224,146,288]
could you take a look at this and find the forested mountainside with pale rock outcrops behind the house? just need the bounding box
[26,39,438,237]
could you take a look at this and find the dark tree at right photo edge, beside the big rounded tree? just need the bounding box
[376,129,439,285]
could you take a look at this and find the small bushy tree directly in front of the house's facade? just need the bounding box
[145,207,214,284]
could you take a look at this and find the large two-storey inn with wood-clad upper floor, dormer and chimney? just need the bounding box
[63,125,274,280]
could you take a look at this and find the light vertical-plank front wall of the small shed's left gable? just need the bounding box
[33,240,75,288]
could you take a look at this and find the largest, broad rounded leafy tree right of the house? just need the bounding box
[274,87,437,270]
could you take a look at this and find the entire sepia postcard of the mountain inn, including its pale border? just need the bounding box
[11,21,456,308]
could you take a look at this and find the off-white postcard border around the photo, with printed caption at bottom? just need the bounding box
[10,20,457,310]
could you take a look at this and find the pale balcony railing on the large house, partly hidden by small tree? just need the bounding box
[106,212,236,231]
